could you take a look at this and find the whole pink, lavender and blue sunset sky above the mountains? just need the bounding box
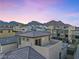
[0,0,79,26]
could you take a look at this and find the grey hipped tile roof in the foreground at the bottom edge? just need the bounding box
[2,46,46,59]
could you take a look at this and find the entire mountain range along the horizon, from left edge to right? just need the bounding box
[0,20,70,26]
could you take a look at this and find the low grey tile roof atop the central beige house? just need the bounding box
[16,31,50,37]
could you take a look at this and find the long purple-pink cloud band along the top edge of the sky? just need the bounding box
[0,0,61,10]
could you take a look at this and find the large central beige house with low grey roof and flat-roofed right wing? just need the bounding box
[17,31,65,59]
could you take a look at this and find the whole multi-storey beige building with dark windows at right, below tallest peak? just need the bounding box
[47,24,75,43]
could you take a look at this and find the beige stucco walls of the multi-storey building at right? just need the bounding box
[48,25,75,43]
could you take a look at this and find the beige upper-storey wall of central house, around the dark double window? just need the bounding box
[19,36,50,47]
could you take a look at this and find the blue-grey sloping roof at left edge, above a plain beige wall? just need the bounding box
[0,36,17,45]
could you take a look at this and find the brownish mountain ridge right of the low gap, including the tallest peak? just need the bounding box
[27,20,71,27]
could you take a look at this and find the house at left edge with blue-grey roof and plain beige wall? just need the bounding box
[0,36,17,53]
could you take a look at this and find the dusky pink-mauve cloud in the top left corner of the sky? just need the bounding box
[0,0,23,10]
